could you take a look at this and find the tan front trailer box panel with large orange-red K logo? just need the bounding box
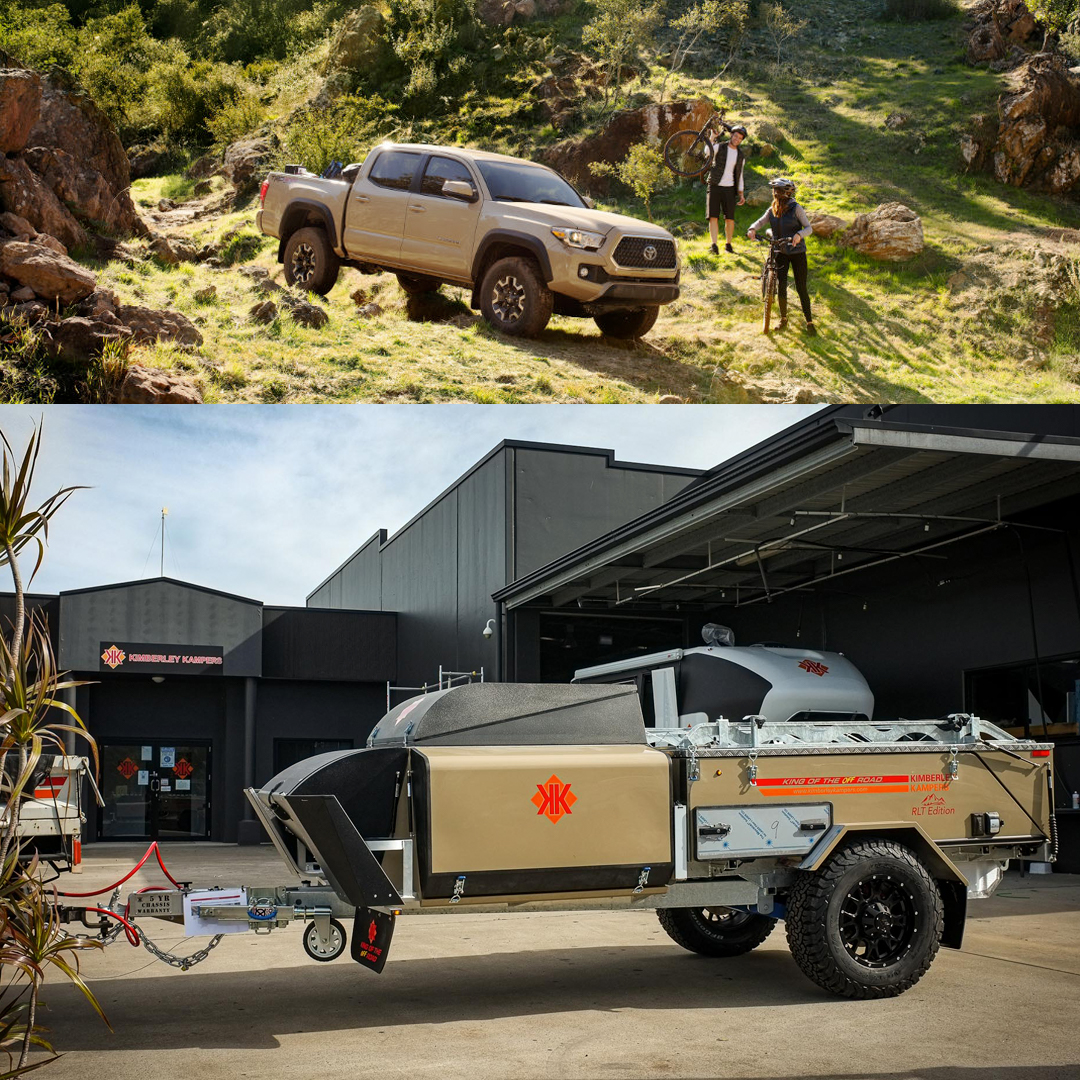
[414,745,672,885]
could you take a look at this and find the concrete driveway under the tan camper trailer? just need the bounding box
[29,845,1080,1080]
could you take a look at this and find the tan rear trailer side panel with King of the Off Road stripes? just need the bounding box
[689,747,1050,842]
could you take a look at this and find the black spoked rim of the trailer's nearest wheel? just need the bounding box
[839,874,919,970]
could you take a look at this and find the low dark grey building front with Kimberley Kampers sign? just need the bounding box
[0,578,396,842]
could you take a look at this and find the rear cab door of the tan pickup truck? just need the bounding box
[345,149,423,262]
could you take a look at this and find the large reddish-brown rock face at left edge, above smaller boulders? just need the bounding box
[0,67,146,247]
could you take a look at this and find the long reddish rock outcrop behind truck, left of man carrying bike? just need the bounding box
[540,97,713,193]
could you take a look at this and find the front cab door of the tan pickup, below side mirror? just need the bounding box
[401,153,481,281]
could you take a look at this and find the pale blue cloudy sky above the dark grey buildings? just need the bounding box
[0,405,818,605]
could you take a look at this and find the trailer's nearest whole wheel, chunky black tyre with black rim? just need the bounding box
[786,839,944,998]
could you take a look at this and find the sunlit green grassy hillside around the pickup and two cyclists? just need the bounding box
[8,0,1080,403]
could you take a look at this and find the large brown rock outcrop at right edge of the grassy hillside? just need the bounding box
[960,53,1080,194]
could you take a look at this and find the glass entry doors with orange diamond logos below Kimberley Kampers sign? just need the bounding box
[97,739,211,840]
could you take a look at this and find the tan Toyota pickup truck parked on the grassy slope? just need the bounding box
[256,144,679,338]
